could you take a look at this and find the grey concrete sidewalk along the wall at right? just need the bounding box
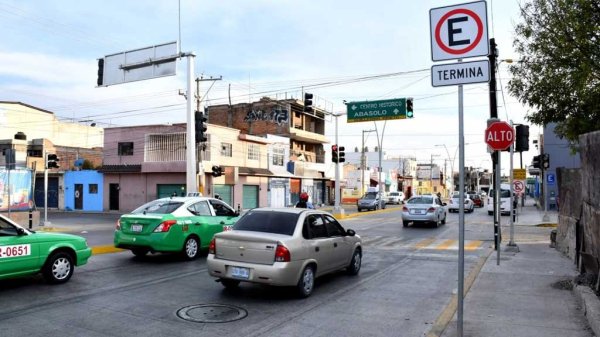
[436,201,600,337]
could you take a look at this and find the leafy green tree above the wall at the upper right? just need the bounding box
[508,0,600,144]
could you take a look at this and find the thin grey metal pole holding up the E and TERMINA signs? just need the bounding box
[456,59,465,336]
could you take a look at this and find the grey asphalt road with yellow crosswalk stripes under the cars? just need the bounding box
[0,207,496,337]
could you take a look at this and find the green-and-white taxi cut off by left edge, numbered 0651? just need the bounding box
[0,214,92,284]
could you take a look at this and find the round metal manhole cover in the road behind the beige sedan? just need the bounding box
[177,304,248,323]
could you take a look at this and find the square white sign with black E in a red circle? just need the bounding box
[429,1,489,61]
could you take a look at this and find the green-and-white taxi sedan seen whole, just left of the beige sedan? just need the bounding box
[114,196,239,260]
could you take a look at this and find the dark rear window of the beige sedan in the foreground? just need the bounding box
[233,211,299,235]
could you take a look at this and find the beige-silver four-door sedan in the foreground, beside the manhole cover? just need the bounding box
[207,208,362,297]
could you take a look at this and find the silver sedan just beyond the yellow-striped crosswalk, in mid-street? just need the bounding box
[402,195,446,227]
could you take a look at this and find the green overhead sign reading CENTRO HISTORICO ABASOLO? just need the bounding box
[346,98,406,123]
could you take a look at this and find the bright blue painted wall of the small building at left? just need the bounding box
[64,170,104,211]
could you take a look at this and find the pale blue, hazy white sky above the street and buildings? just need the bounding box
[0,0,541,173]
